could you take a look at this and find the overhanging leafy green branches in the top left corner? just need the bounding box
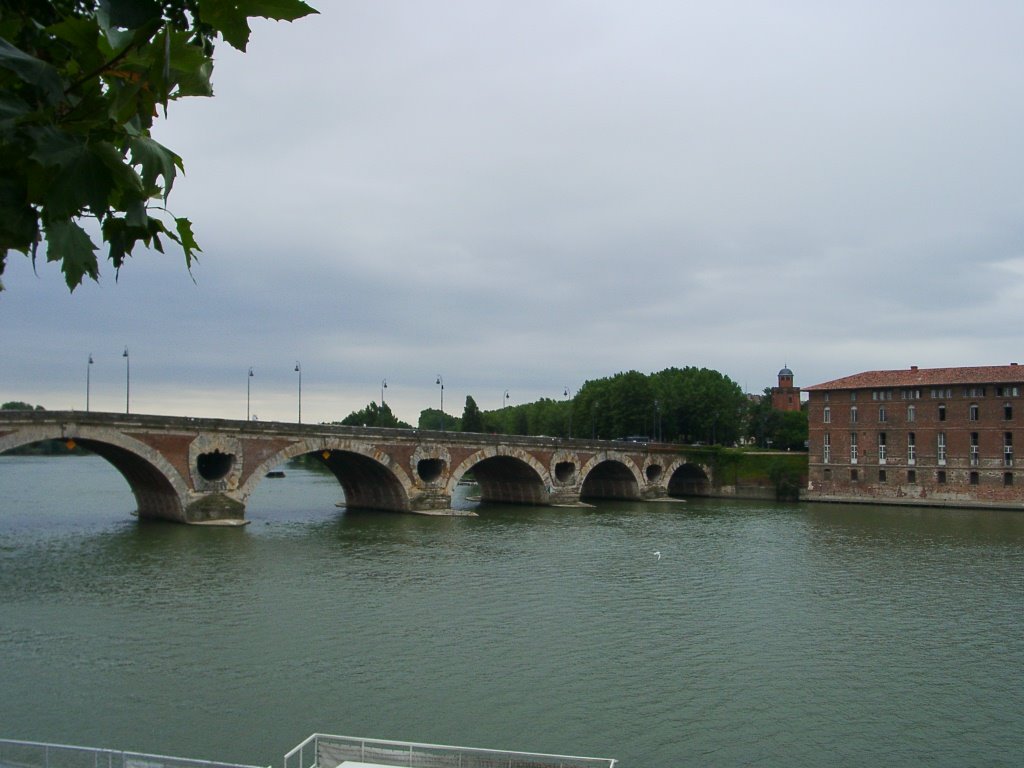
[0,0,315,291]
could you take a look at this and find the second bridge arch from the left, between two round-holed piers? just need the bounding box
[238,437,415,512]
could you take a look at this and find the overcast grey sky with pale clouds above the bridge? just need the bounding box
[0,0,1024,423]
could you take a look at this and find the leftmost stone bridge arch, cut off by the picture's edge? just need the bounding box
[0,423,189,522]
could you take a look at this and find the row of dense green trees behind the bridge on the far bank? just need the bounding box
[341,367,807,450]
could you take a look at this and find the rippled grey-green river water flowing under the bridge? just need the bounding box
[0,457,1024,768]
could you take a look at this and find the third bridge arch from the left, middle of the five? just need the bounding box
[445,445,551,506]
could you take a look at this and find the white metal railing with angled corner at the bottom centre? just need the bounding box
[285,733,615,768]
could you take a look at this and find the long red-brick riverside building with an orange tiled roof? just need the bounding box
[804,362,1024,509]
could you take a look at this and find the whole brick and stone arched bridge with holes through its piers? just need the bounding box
[0,411,713,524]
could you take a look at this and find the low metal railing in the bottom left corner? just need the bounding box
[0,738,268,768]
